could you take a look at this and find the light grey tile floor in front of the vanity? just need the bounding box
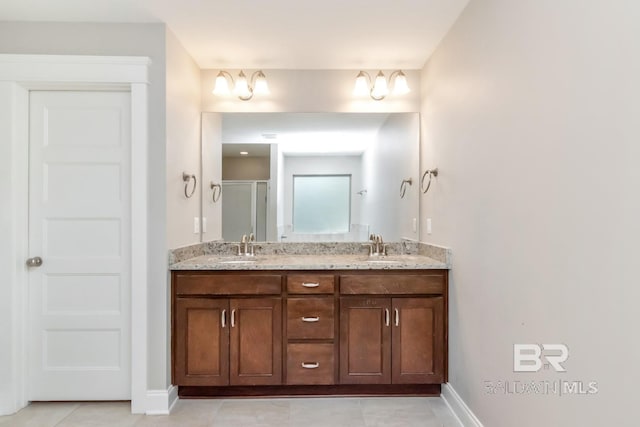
[0,397,461,427]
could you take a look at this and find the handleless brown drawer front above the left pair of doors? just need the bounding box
[176,274,282,296]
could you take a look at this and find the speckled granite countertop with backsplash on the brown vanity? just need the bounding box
[169,243,451,270]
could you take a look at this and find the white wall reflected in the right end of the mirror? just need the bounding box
[358,114,420,241]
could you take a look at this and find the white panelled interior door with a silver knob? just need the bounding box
[28,91,131,400]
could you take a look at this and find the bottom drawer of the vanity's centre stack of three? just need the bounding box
[287,344,334,385]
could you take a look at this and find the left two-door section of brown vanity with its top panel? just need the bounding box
[172,273,282,386]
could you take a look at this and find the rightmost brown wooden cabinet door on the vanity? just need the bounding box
[391,297,444,384]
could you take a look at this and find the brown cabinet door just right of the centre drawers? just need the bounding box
[340,297,391,384]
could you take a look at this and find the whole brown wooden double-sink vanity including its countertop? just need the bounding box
[171,246,448,397]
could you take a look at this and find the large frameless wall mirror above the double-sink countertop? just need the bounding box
[202,113,419,242]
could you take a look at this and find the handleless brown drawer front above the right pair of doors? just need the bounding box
[340,270,445,295]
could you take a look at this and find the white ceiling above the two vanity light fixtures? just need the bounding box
[0,0,469,70]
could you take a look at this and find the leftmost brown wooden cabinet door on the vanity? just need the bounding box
[173,298,229,385]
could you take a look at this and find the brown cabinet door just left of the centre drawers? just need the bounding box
[229,297,282,385]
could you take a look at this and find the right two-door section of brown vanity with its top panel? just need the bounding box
[340,273,446,384]
